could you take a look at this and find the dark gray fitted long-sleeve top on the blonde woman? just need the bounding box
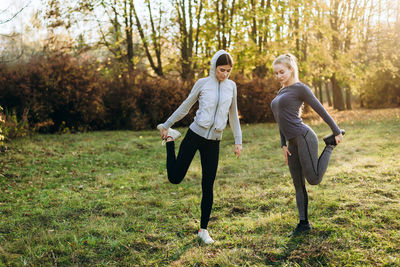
[271,82,340,146]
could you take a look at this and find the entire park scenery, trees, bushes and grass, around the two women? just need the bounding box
[0,0,400,266]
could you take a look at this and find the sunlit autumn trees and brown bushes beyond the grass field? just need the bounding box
[0,0,400,139]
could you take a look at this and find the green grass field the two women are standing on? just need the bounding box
[0,109,400,266]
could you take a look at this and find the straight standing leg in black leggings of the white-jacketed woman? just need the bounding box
[199,139,219,229]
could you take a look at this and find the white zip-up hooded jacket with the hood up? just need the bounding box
[163,50,242,144]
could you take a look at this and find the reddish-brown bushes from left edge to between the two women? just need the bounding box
[0,53,279,136]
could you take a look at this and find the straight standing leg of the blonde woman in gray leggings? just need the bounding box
[288,139,308,221]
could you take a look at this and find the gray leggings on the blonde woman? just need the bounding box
[288,128,334,220]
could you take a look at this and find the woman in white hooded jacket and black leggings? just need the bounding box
[157,50,242,244]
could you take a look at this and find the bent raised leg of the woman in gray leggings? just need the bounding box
[295,128,334,185]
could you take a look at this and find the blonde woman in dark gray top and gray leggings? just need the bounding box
[271,54,344,237]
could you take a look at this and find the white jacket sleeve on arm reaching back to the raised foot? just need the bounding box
[163,79,205,129]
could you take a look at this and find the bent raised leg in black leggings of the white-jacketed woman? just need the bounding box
[166,129,201,184]
